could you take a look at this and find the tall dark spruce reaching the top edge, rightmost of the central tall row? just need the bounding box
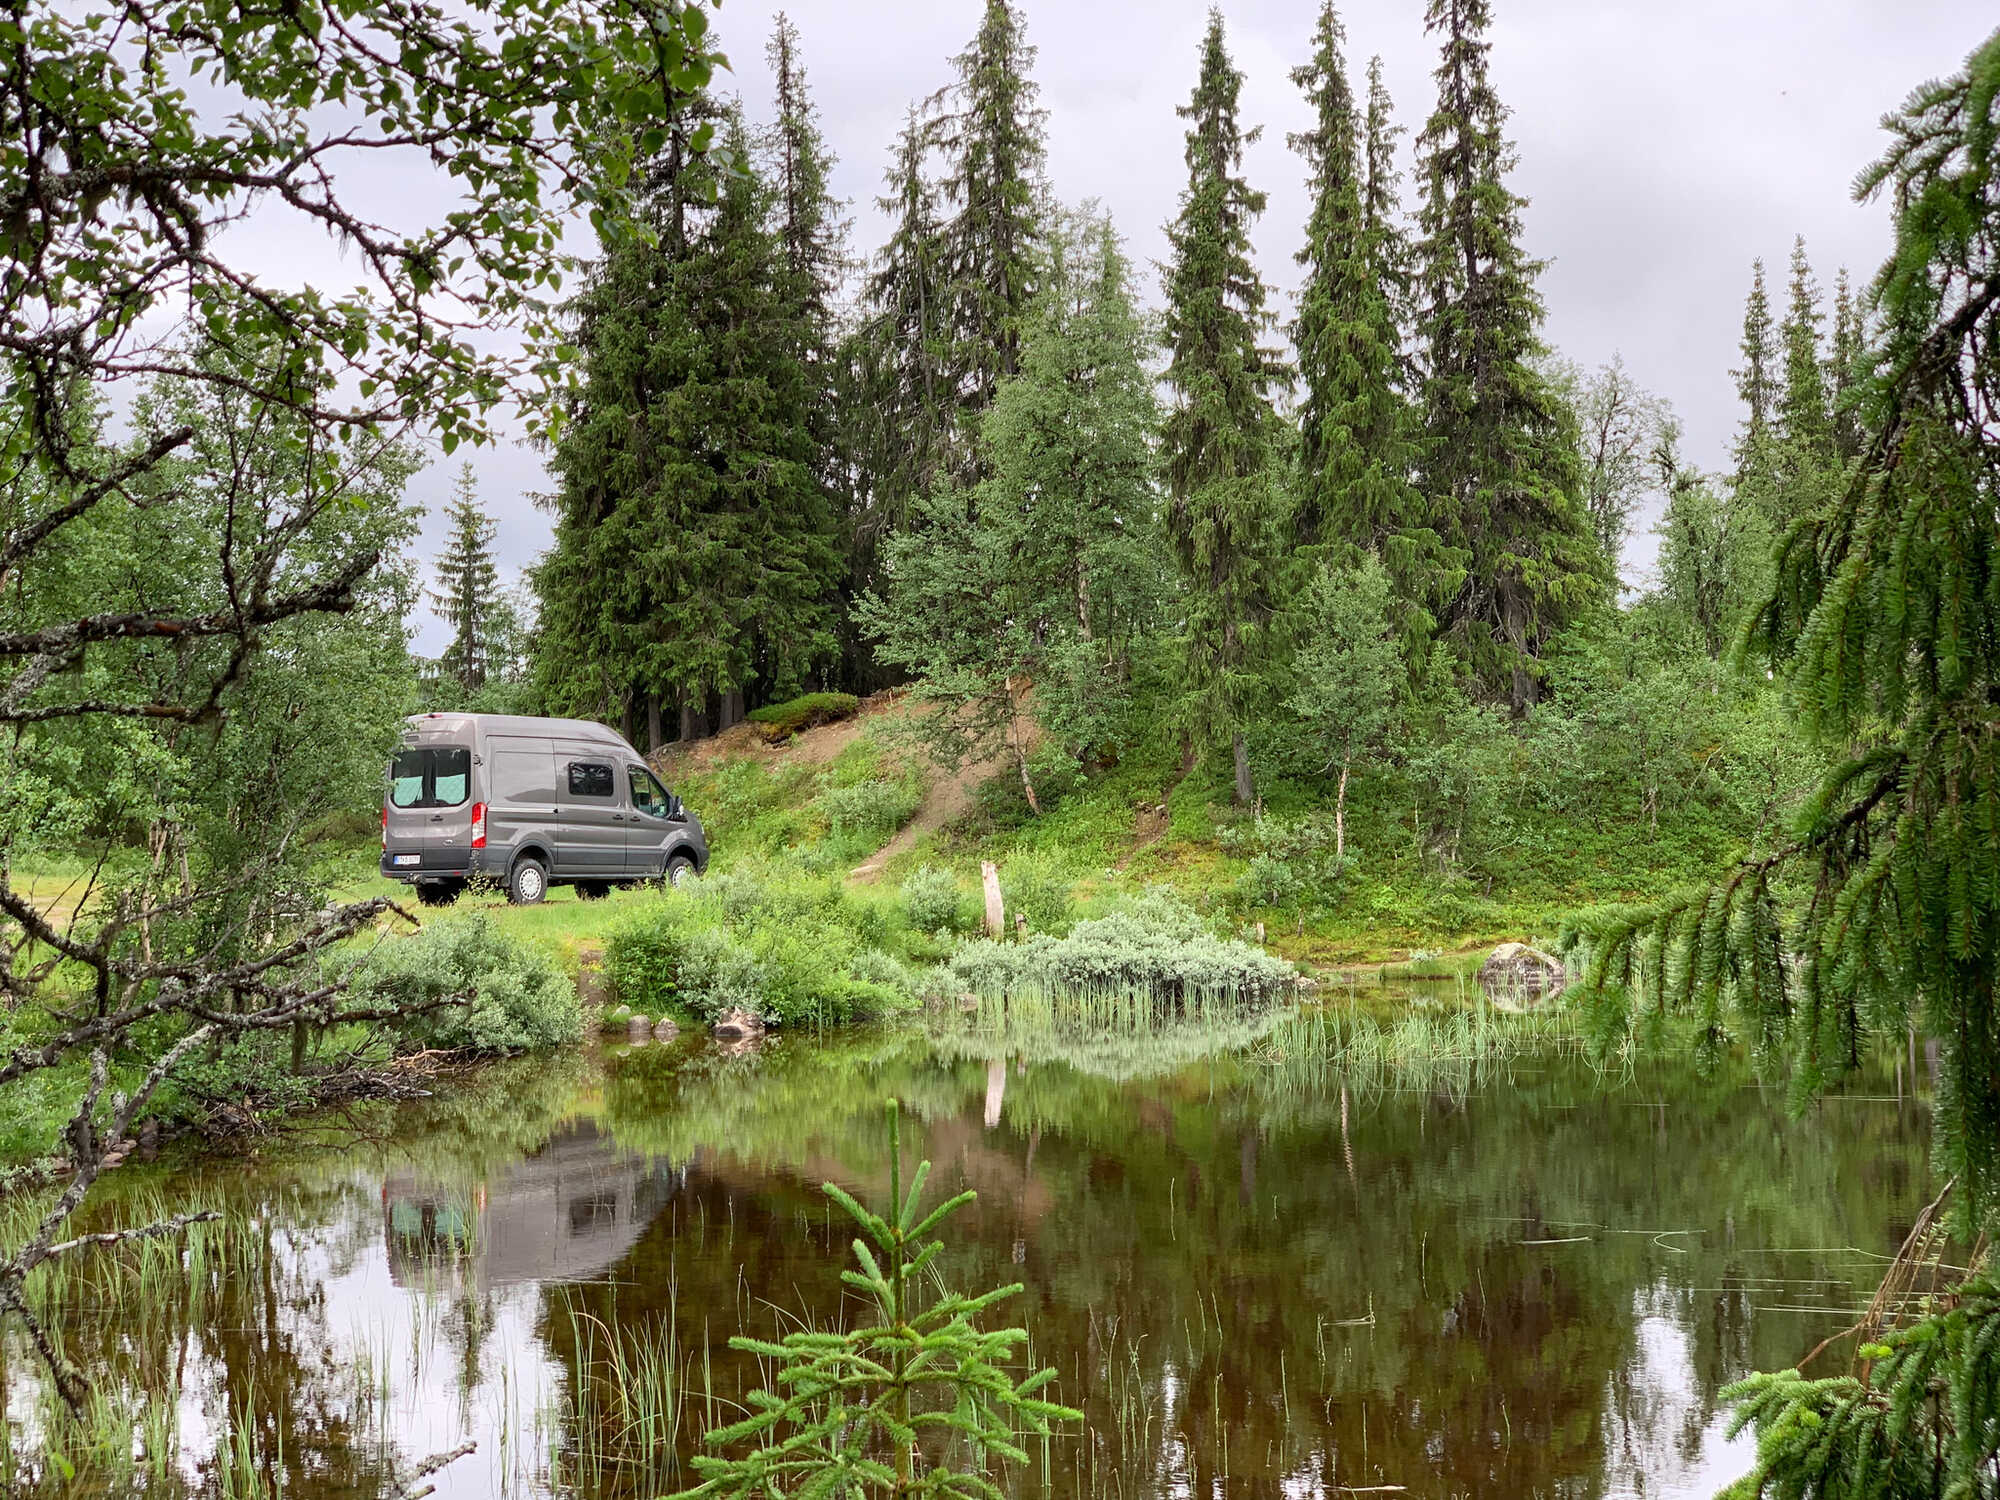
[1418,0,1606,714]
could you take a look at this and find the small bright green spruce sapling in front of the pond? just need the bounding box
[676,1100,1082,1500]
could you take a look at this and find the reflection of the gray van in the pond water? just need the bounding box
[382,1122,688,1290]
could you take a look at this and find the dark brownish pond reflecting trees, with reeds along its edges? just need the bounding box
[0,1012,1934,1500]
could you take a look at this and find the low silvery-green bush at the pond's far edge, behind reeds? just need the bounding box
[946,894,1296,1004]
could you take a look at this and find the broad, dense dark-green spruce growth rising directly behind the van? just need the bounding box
[536,112,838,740]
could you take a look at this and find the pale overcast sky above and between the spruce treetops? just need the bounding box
[398,0,1994,652]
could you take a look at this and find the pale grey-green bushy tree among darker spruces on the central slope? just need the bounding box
[862,216,1164,812]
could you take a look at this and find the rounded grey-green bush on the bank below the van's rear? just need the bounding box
[342,912,584,1052]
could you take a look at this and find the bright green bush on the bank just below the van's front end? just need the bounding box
[604,874,916,1026]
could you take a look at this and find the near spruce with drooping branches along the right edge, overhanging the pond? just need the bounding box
[1574,32,2000,1500]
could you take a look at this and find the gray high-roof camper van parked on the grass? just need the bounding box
[382,714,708,906]
